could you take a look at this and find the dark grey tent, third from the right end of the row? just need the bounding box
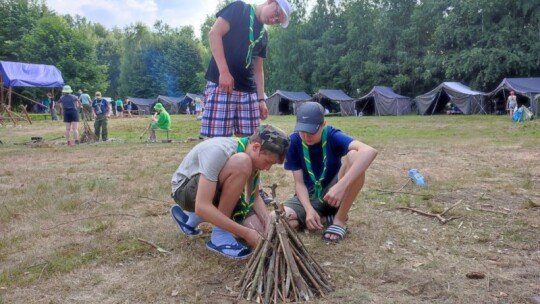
[356,86,411,116]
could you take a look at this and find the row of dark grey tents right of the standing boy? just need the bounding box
[266,78,540,116]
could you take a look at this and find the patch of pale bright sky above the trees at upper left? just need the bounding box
[45,0,219,37]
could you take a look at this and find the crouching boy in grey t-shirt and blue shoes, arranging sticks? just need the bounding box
[170,125,289,259]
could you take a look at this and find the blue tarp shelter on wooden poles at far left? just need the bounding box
[0,61,64,106]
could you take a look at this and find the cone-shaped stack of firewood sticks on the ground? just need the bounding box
[236,202,333,303]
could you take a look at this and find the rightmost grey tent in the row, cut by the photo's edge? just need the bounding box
[488,77,540,116]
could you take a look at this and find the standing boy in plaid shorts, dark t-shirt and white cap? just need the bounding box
[200,0,290,137]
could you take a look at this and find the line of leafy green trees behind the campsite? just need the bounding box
[0,0,540,107]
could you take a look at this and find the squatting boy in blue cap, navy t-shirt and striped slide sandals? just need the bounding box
[284,102,377,242]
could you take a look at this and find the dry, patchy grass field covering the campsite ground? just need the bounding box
[0,116,540,303]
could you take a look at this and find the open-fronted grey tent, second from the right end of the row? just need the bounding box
[414,82,487,115]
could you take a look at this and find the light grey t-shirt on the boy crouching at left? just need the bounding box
[171,137,238,193]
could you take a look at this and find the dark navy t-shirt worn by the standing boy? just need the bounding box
[205,1,268,93]
